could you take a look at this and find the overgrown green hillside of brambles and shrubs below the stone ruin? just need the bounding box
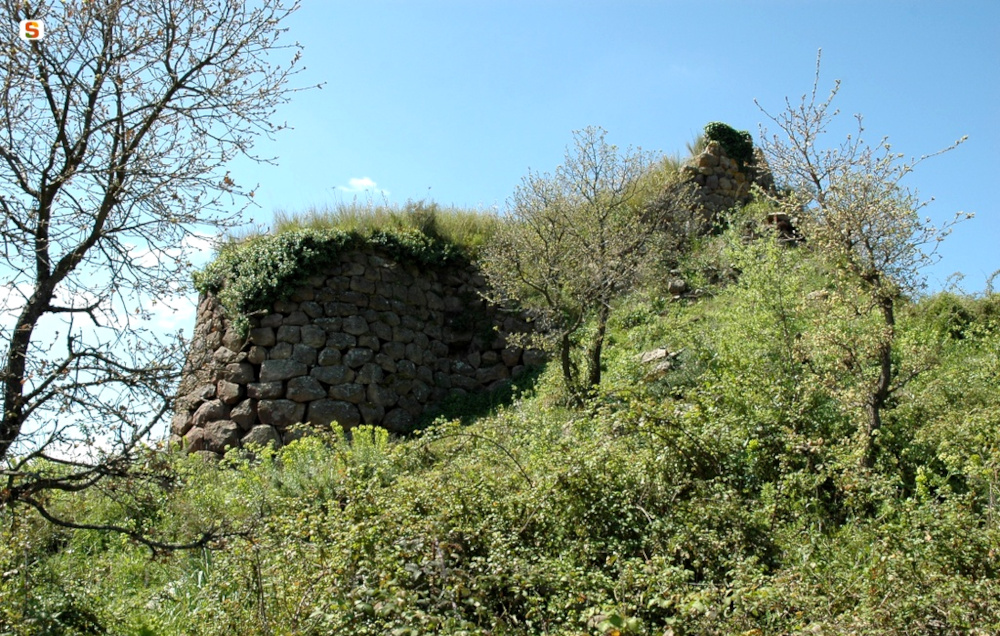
[0,211,1000,636]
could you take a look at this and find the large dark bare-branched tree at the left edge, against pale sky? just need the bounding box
[0,0,308,548]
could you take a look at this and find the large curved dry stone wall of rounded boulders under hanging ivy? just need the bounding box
[171,251,542,453]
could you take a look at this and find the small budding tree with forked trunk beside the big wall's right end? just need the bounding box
[483,127,688,399]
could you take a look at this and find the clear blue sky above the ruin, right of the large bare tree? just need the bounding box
[233,0,1000,291]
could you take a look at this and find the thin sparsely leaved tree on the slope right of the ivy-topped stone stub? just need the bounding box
[758,56,971,467]
